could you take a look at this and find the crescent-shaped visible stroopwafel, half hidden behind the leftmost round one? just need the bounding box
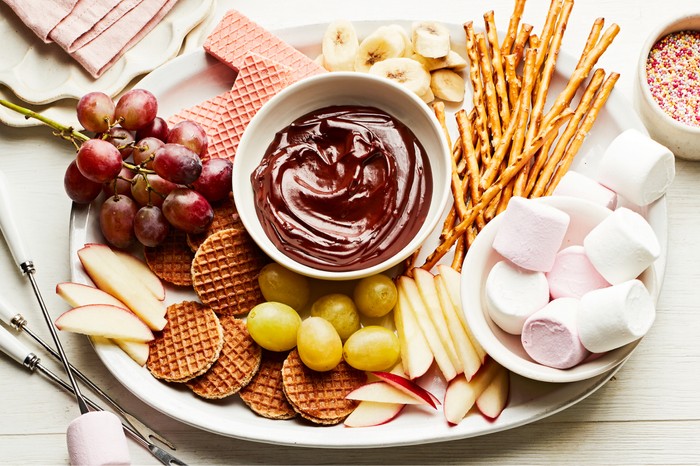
[187,316,262,399]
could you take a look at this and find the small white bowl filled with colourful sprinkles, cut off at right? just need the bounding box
[634,12,700,160]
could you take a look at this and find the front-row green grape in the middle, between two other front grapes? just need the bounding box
[297,317,343,372]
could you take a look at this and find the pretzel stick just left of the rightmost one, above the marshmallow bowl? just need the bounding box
[526,69,605,197]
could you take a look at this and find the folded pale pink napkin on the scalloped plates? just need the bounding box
[3,0,177,78]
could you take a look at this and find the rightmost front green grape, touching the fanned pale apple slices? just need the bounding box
[343,325,400,371]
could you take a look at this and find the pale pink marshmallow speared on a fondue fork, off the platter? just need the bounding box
[66,411,131,466]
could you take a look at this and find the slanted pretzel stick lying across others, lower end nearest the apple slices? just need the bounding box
[421,109,573,270]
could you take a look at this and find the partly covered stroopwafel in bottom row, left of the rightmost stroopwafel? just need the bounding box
[238,350,297,419]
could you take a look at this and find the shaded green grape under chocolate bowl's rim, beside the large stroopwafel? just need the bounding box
[258,262,311,311]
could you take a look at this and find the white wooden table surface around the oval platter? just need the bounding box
[0,0,700,465]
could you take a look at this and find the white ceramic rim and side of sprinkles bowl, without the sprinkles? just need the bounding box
[634,11,700,160]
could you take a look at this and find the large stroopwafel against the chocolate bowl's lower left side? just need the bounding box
[192,228,270,315]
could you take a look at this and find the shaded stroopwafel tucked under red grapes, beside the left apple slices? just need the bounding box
[143,228,194,286]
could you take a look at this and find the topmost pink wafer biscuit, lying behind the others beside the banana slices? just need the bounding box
[204,10,325,81]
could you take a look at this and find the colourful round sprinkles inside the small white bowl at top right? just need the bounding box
[646,31,700,127]
